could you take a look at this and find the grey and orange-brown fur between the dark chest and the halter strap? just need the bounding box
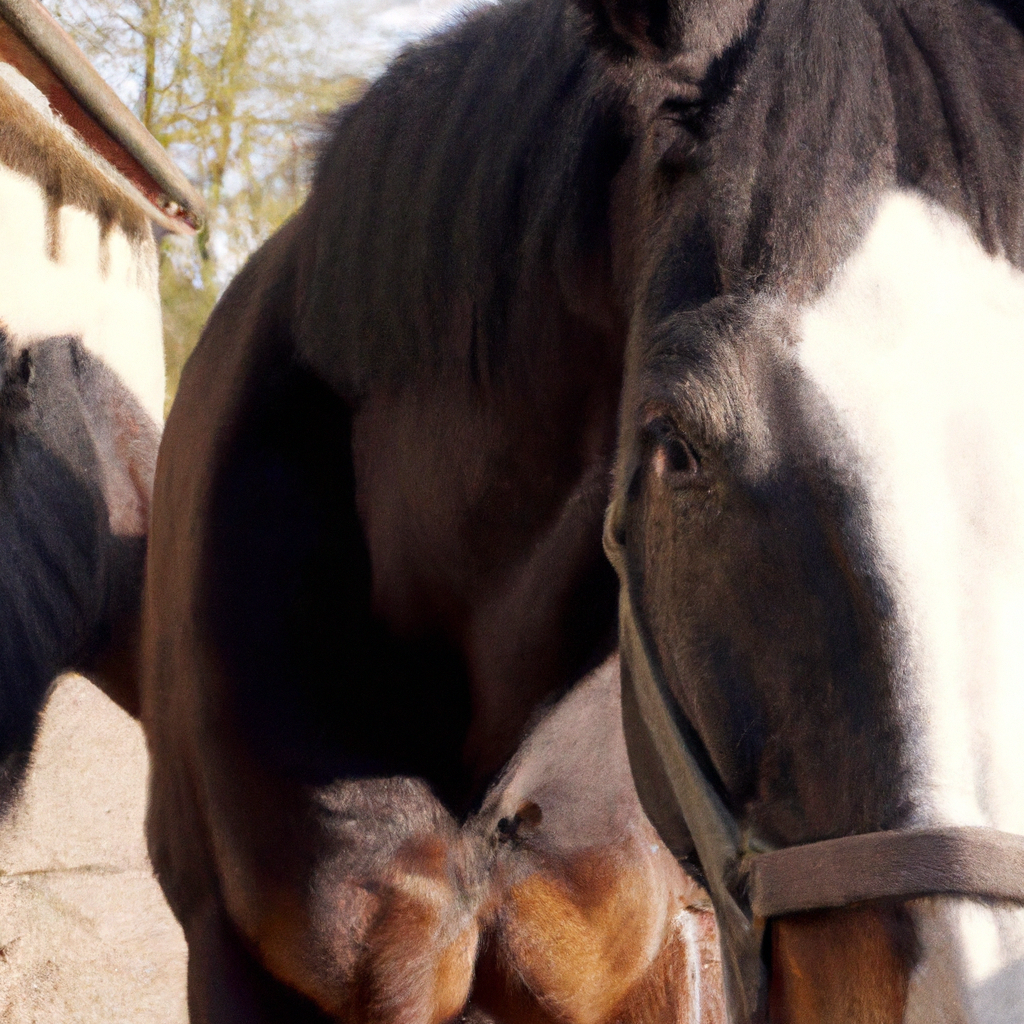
[467,658,722,1024]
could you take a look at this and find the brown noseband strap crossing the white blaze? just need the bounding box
[744,827,1024,918]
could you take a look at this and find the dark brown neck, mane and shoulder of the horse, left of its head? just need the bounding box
[142,4,627,1021]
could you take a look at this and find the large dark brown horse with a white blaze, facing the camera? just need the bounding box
[141,0,1024,1024]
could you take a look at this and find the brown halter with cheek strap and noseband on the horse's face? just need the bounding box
[604,509,1024,1024]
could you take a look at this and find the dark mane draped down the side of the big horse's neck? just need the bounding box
[298,0,627,397]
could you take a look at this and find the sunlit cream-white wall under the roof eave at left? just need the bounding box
[0,66,164,423]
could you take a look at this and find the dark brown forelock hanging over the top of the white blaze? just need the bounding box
[700,0,1024,294]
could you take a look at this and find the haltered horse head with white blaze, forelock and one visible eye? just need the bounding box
[588,0,1024,1024]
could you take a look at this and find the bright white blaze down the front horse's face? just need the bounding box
[798,193,1024,1021]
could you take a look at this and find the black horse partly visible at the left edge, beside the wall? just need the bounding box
[0,332,160,810]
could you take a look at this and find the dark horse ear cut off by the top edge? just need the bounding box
[577,0,755,63]
